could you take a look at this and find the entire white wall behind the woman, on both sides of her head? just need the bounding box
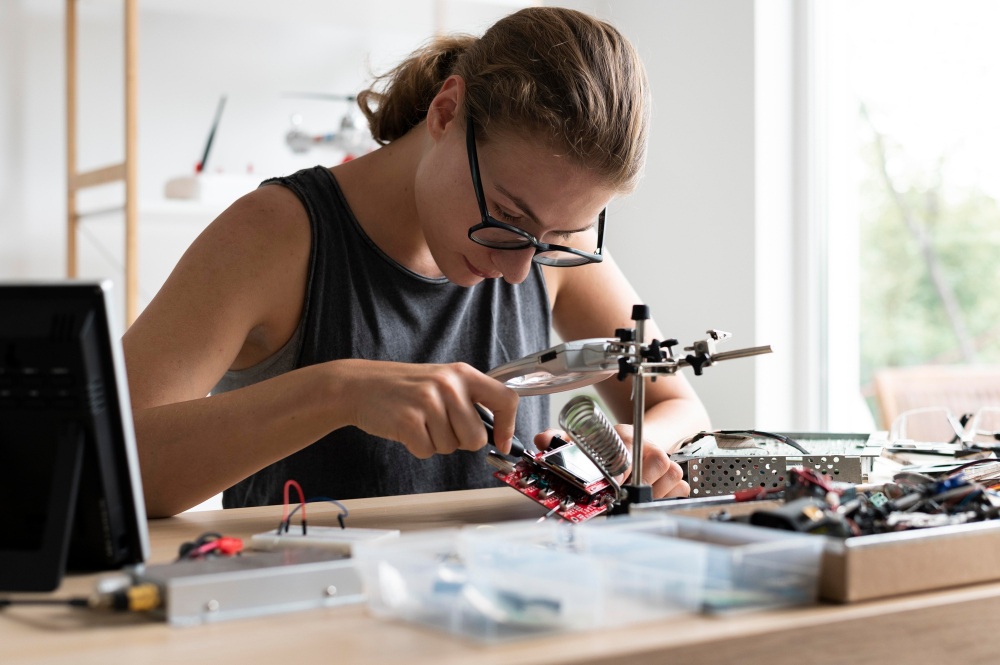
[0,0,808,436]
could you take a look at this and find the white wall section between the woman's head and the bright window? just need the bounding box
[572,0,808,430]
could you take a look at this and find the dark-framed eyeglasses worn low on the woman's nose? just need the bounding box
[465,116,607,267]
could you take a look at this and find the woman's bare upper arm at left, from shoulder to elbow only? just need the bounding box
[123,185,311,404]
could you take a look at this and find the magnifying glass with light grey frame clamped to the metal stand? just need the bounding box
[487,338,620,395]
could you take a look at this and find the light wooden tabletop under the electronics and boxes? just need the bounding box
[0,488,1000,665]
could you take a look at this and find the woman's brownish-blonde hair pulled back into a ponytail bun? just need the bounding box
[358,7,649,192]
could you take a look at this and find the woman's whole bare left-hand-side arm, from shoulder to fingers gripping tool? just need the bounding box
[123,186,517,516]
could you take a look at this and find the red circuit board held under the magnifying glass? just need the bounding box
[493,460,615,523]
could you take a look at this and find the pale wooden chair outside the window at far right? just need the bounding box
[874,365,1000,441]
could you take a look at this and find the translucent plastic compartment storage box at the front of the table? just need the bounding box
[354,516,824,642]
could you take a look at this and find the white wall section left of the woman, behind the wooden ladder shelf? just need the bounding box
[0,0,527,306]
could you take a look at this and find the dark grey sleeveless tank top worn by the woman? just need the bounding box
[222,166,551,508]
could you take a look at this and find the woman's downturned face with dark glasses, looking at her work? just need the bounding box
[417,122,615,286]
